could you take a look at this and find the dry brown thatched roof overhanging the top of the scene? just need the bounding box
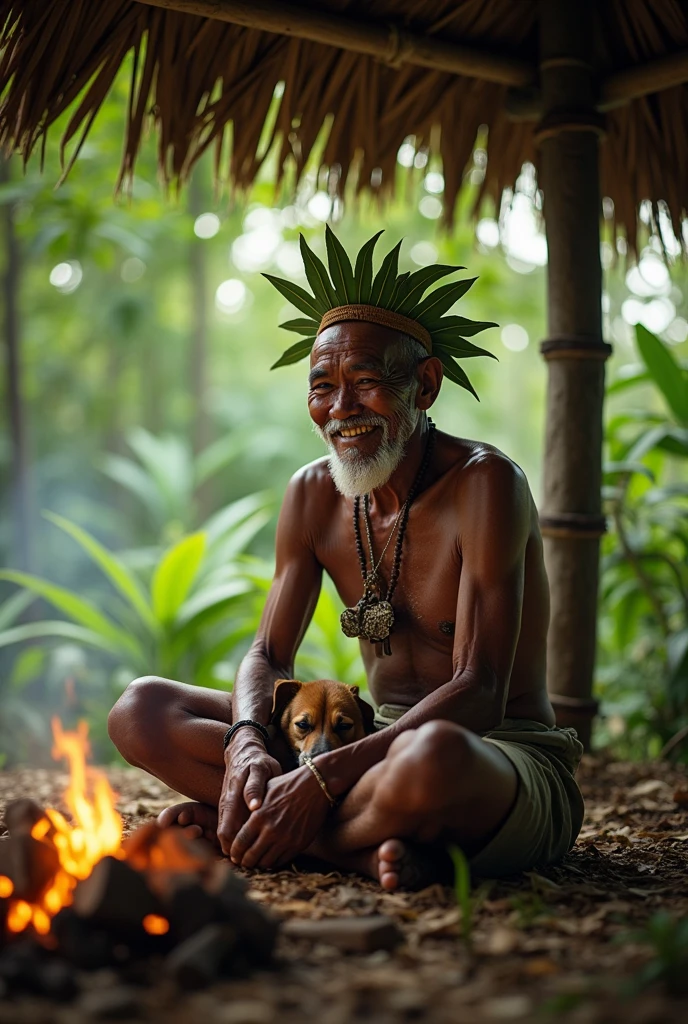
[0,0,688,242]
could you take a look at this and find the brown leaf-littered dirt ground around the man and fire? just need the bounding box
[0,757,688,1024]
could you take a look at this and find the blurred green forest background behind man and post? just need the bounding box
[0,72,688,766]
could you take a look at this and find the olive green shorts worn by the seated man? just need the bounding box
[375,705,584,878]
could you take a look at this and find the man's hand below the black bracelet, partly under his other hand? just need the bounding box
[217,729,282,856]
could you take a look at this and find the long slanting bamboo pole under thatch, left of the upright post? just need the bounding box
[137,0,535,86]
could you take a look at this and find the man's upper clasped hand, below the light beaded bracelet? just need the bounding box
[228,767,330,868]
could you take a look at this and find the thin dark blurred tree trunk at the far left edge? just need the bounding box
[0,157,32,570]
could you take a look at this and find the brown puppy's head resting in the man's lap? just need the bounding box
[271,679,375,764]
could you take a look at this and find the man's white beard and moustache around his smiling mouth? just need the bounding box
[314,399,421,498]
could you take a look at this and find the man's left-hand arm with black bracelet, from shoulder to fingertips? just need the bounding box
[218,467,323,853]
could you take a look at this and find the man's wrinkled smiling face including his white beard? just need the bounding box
[308,322,420,497]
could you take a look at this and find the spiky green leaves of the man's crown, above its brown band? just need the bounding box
[263,225,498,398]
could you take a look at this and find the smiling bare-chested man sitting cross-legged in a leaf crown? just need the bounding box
[110,229,583,889]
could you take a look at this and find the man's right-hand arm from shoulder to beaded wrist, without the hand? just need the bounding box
[317,455,532,797]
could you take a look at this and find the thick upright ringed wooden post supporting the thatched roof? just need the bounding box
[536,0,611,745]
